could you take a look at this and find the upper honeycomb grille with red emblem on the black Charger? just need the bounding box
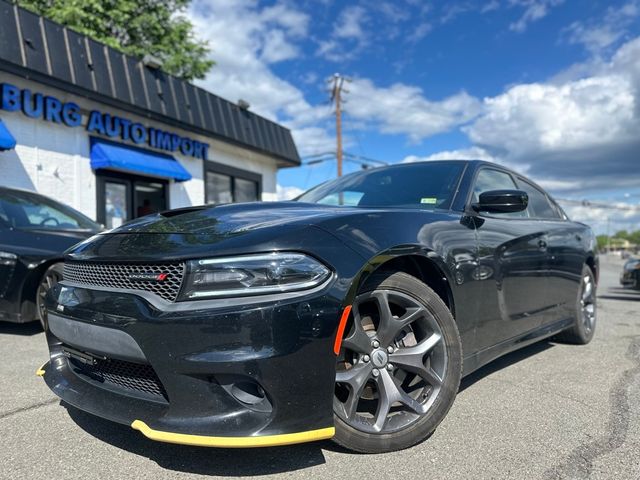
[63,262,185,302]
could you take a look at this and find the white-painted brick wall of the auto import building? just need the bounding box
[0,73,278,219]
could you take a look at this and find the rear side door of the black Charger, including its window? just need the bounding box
[472,167,549,349]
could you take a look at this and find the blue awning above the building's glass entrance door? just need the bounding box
[91,137,191,182]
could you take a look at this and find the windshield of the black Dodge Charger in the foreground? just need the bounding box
[297,161,465,210]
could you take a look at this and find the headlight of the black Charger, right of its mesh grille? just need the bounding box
[180,253,331,300]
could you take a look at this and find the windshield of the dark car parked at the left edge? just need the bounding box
[0,190,100,232]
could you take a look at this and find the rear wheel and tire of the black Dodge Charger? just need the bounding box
[556,265,597,345]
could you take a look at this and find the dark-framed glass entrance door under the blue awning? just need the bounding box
[97,172,168,229]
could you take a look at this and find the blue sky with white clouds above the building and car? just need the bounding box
[187,0,640,231]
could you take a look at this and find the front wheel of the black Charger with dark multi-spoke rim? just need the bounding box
[334,272,462,453]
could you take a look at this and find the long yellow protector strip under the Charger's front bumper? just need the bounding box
[131,420,336,448]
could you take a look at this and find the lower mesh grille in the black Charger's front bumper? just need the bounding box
[69,357,168,400]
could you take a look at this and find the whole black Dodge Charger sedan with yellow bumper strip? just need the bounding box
[37,161,598,452]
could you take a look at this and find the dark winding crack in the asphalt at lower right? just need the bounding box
[544,338,640,478]
